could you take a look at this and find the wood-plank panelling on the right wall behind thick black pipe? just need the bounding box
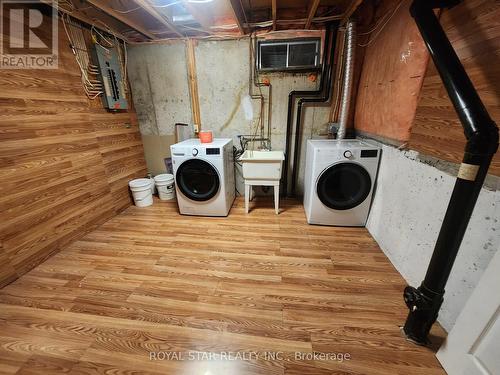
[410,0,500,175]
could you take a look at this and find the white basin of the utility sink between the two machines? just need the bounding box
[239,150,285,180]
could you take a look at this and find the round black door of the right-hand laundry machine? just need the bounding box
[316,163,372,210]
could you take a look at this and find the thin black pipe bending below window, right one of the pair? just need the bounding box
[282,24,335,197]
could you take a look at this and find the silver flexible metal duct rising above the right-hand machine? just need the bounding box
[337,21,356,139]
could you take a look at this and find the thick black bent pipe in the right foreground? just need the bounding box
[403,0,498,345]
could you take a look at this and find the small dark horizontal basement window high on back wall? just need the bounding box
[257,38,320,72]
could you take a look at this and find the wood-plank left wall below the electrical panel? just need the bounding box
[0,13,146,287]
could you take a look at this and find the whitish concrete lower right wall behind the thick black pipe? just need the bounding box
[367,145,500,331]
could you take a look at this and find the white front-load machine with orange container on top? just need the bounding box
[170,139,235,216]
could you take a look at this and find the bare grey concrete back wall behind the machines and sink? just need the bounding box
[128,38,330,192]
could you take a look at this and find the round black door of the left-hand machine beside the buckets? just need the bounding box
[175,159,220,202]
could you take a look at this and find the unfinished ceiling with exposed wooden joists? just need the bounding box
[53,0,352,42]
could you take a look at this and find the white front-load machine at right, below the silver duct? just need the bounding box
[304,139,380,226]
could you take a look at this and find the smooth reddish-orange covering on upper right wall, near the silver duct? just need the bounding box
[354,0,429,143]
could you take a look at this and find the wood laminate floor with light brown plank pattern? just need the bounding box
[0,198,444,375]
